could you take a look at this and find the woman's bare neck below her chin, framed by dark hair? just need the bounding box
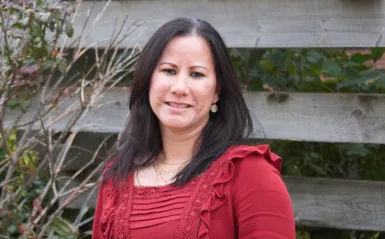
[161,122,204,164]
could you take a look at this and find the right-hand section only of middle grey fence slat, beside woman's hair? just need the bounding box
[245,93,385,144]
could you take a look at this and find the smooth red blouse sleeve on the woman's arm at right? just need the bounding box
[232,154,295,239]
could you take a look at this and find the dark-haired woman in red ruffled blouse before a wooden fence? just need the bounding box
[93,18,295,239]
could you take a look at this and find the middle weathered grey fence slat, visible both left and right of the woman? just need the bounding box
[5,89,385,144]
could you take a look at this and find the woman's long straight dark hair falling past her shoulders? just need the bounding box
[104,18,253,186]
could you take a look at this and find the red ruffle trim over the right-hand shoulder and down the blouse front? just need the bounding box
[198,145,282,239]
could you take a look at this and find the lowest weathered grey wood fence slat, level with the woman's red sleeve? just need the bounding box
[61,177,385,231]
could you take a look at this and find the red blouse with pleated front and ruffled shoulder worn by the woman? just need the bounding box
[92,145,295,239]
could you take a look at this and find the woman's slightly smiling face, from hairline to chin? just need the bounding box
[149,36,219,131]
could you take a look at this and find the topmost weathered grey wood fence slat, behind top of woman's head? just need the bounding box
[68,0,385,48]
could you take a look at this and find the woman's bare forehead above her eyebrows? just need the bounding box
[161,36,213,63]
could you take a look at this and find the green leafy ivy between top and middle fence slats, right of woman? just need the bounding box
[230,48,385,93]
